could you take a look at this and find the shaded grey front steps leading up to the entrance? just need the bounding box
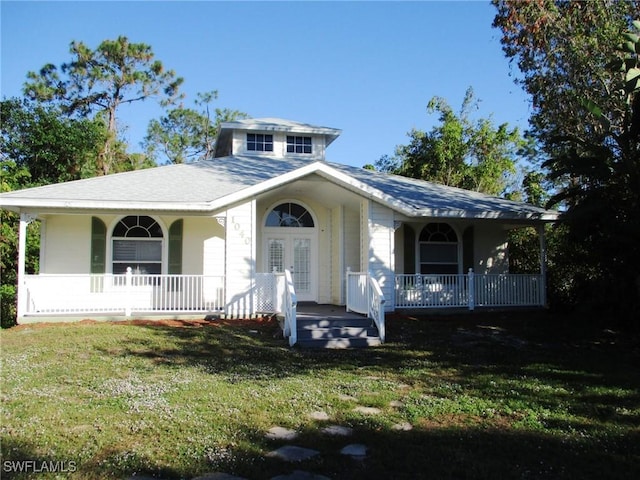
[297,316,382,348]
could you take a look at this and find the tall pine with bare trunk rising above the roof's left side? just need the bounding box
[24,36,183,175]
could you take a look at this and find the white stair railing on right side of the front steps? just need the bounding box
[346,270,386,342]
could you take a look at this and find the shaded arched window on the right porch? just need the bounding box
[418,223,458,274]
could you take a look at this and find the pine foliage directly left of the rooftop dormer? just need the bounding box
[144,90,247,163]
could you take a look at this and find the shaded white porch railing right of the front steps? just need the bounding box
[395,270,544,310]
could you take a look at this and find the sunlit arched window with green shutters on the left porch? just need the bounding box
[112,215,163,274]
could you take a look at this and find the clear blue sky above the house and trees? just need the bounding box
[0,0,531,166]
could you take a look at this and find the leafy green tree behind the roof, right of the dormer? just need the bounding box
[376,88,523,195]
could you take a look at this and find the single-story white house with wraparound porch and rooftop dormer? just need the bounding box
[0,118,557,344]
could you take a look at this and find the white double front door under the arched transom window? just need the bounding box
[265,232,317,302]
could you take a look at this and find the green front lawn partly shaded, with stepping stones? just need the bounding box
[0,313,640,479]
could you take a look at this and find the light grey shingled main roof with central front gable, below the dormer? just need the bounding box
[0,156,558,221]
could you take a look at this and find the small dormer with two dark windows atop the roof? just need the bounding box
[215,118,342,161]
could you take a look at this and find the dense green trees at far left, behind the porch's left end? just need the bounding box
[0,98,115,327]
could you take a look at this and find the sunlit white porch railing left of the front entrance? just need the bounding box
[24,271,225,316]
